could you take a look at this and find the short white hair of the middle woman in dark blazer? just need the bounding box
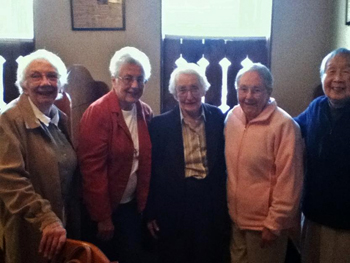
[169,63,210,97]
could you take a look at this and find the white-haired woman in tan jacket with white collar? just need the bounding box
[0,50,77,263]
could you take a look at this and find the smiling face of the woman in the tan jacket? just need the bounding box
[22,59,58,115]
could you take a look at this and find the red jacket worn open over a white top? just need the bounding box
[78,91,152,222]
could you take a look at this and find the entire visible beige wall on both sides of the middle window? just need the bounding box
[34,0,344,116]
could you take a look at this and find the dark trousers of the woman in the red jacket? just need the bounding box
[82,201,152,263]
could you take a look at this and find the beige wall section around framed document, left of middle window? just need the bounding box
[34,0,161,113]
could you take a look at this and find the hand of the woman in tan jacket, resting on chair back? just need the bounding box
[39,222,67,259]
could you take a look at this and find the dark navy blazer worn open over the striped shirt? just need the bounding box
[146,104,227,238]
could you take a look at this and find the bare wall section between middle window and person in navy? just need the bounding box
[271,0,333,116]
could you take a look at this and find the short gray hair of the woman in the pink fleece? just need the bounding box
[235,63,273,95]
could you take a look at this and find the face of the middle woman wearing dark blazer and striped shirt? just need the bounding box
[175,73,205,117]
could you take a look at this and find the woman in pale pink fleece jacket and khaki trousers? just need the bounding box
[225,63,302,263]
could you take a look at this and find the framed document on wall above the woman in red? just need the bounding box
[70,0,125,30]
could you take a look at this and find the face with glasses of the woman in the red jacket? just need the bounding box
[112,64,145,110]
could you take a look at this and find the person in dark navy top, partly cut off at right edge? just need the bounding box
[296,48,350,263]
